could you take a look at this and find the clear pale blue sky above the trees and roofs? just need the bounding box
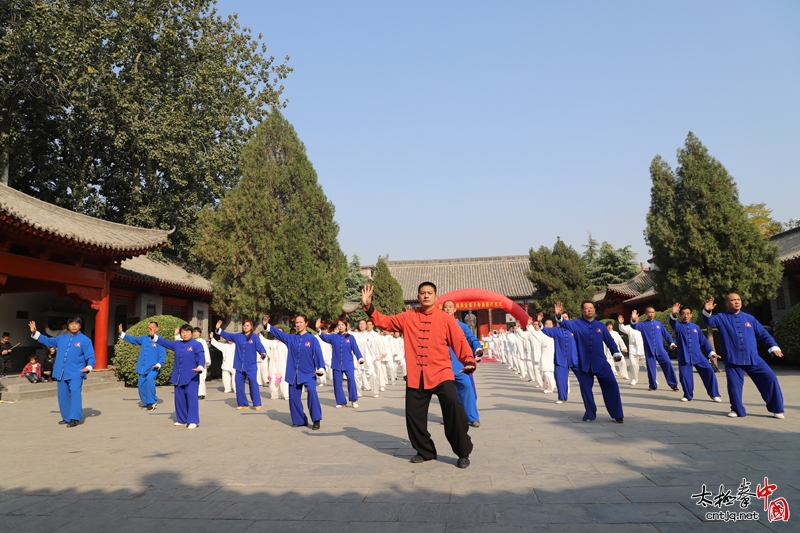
[218,0,800,264]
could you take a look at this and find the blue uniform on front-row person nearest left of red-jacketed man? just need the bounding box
[267,324,326,426]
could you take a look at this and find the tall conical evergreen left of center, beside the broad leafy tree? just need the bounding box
[195,110,347,318]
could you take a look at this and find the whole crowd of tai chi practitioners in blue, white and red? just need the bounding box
[21,288,784,468]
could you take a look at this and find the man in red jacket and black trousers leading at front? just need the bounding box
[361,281,476,468]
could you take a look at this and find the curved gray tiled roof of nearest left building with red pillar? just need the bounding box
[0,184,172,252]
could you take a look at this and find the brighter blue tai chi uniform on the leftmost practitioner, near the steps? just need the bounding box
[31,331,95,422]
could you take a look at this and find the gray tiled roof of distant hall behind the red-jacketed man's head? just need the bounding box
[387,255,534,301]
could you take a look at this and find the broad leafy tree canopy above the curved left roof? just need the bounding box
[0,0,291,258]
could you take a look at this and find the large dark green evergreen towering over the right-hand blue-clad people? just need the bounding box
[645,132,782,309]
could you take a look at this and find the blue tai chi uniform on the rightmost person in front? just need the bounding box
[702,310,783,416]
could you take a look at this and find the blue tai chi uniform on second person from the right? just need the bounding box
[669,315,719,400]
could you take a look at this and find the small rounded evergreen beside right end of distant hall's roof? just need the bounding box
[526,237,591,317]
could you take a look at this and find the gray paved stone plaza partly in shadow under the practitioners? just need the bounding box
[0,363,800,533]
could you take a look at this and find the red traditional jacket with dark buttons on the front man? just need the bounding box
[364,306,475,389]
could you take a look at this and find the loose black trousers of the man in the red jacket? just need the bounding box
[406,381,472,460]
